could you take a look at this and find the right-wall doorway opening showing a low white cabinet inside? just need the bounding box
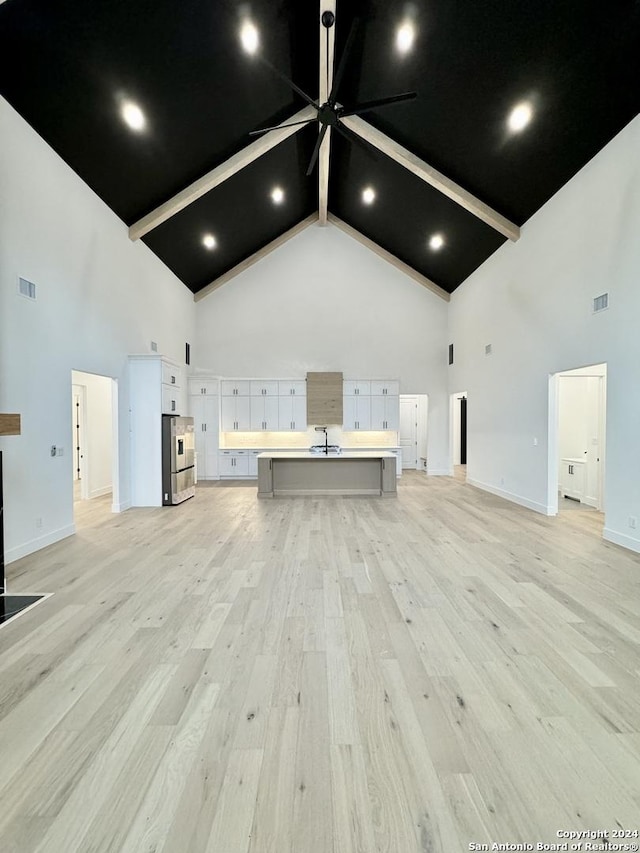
[549,364,607,513]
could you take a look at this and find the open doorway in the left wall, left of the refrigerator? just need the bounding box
[71,370,118,510]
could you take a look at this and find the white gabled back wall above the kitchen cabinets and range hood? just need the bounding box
[193,225,449,473]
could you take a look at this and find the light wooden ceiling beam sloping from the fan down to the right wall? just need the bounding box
[341,116,520,242]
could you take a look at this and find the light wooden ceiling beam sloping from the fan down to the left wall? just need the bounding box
[129,106,317,240]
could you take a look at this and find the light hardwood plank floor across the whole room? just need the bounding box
[0,472,640,853]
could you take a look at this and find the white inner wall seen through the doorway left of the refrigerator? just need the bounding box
[69,370,113,498]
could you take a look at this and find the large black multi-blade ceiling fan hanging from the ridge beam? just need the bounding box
[249,11,417,176]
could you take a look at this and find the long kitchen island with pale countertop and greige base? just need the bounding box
[258,450,397,498]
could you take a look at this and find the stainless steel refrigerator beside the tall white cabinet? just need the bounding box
[162,415,196,506]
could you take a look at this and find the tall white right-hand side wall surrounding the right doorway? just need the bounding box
[449,117,640,550]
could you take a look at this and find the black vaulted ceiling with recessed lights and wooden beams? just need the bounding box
[0,0,640,295]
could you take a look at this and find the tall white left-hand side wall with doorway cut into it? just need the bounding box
[0,99,195,561]
